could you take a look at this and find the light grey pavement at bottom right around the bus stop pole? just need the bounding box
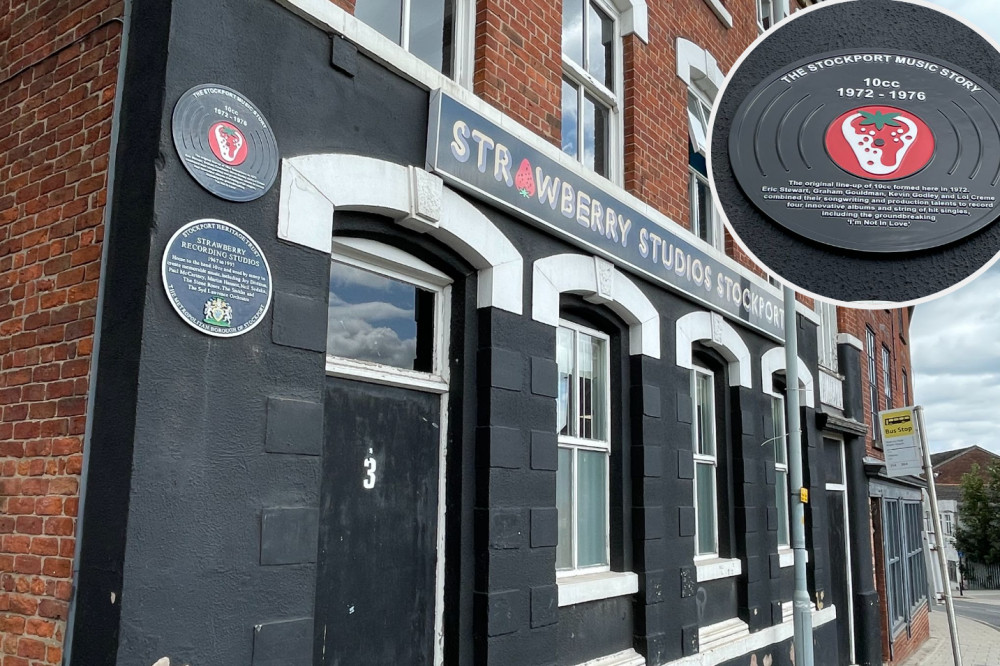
[900,590,1000,666]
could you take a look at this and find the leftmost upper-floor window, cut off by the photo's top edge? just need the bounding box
[354,0,472,78]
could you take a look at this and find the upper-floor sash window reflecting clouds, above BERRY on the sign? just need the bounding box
[562,0,622,180]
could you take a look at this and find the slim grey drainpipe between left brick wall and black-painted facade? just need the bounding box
[62,0,132,666]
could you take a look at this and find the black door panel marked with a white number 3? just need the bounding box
[314,377,441,666]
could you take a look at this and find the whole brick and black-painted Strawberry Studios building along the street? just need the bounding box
[0,0,927,666]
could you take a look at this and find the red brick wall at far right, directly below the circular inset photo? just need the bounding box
[837,308,916,458]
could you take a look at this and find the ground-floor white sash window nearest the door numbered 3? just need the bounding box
[556,321,611,575]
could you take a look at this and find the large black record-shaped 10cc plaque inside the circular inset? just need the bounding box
[729,48,1000,253]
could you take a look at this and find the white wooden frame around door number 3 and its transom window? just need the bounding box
[326,236,452,666]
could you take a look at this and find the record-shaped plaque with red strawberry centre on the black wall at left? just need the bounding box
[172,84,278,201]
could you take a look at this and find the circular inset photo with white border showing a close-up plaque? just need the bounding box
[709,0,1000,307]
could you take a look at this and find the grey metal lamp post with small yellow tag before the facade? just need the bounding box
[782,287,813,666]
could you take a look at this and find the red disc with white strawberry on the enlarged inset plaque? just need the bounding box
[826,106,934,180]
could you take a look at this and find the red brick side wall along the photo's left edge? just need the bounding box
[0,0,121,666]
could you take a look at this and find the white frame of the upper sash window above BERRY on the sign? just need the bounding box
[564,0,625,185]
